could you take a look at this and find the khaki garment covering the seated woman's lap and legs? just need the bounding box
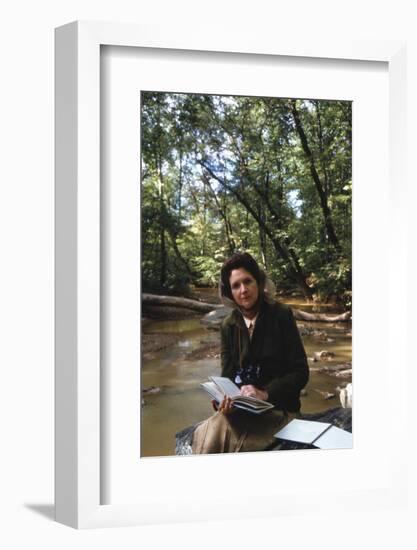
[192,410,300,454]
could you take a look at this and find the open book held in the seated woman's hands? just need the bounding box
[201,376,274,414]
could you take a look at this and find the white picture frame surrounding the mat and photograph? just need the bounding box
[55,22,407,528]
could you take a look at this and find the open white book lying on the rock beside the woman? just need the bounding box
[274,418,353,449]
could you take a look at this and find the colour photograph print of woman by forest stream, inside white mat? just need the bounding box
[138,91,353,458]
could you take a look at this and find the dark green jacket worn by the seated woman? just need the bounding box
[221,302,309,412]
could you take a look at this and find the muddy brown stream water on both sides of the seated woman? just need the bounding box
[141,312,352,457]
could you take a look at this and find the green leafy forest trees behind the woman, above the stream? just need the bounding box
[141,92,352,306]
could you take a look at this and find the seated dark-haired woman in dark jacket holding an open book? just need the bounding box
[192,253,309,454]
